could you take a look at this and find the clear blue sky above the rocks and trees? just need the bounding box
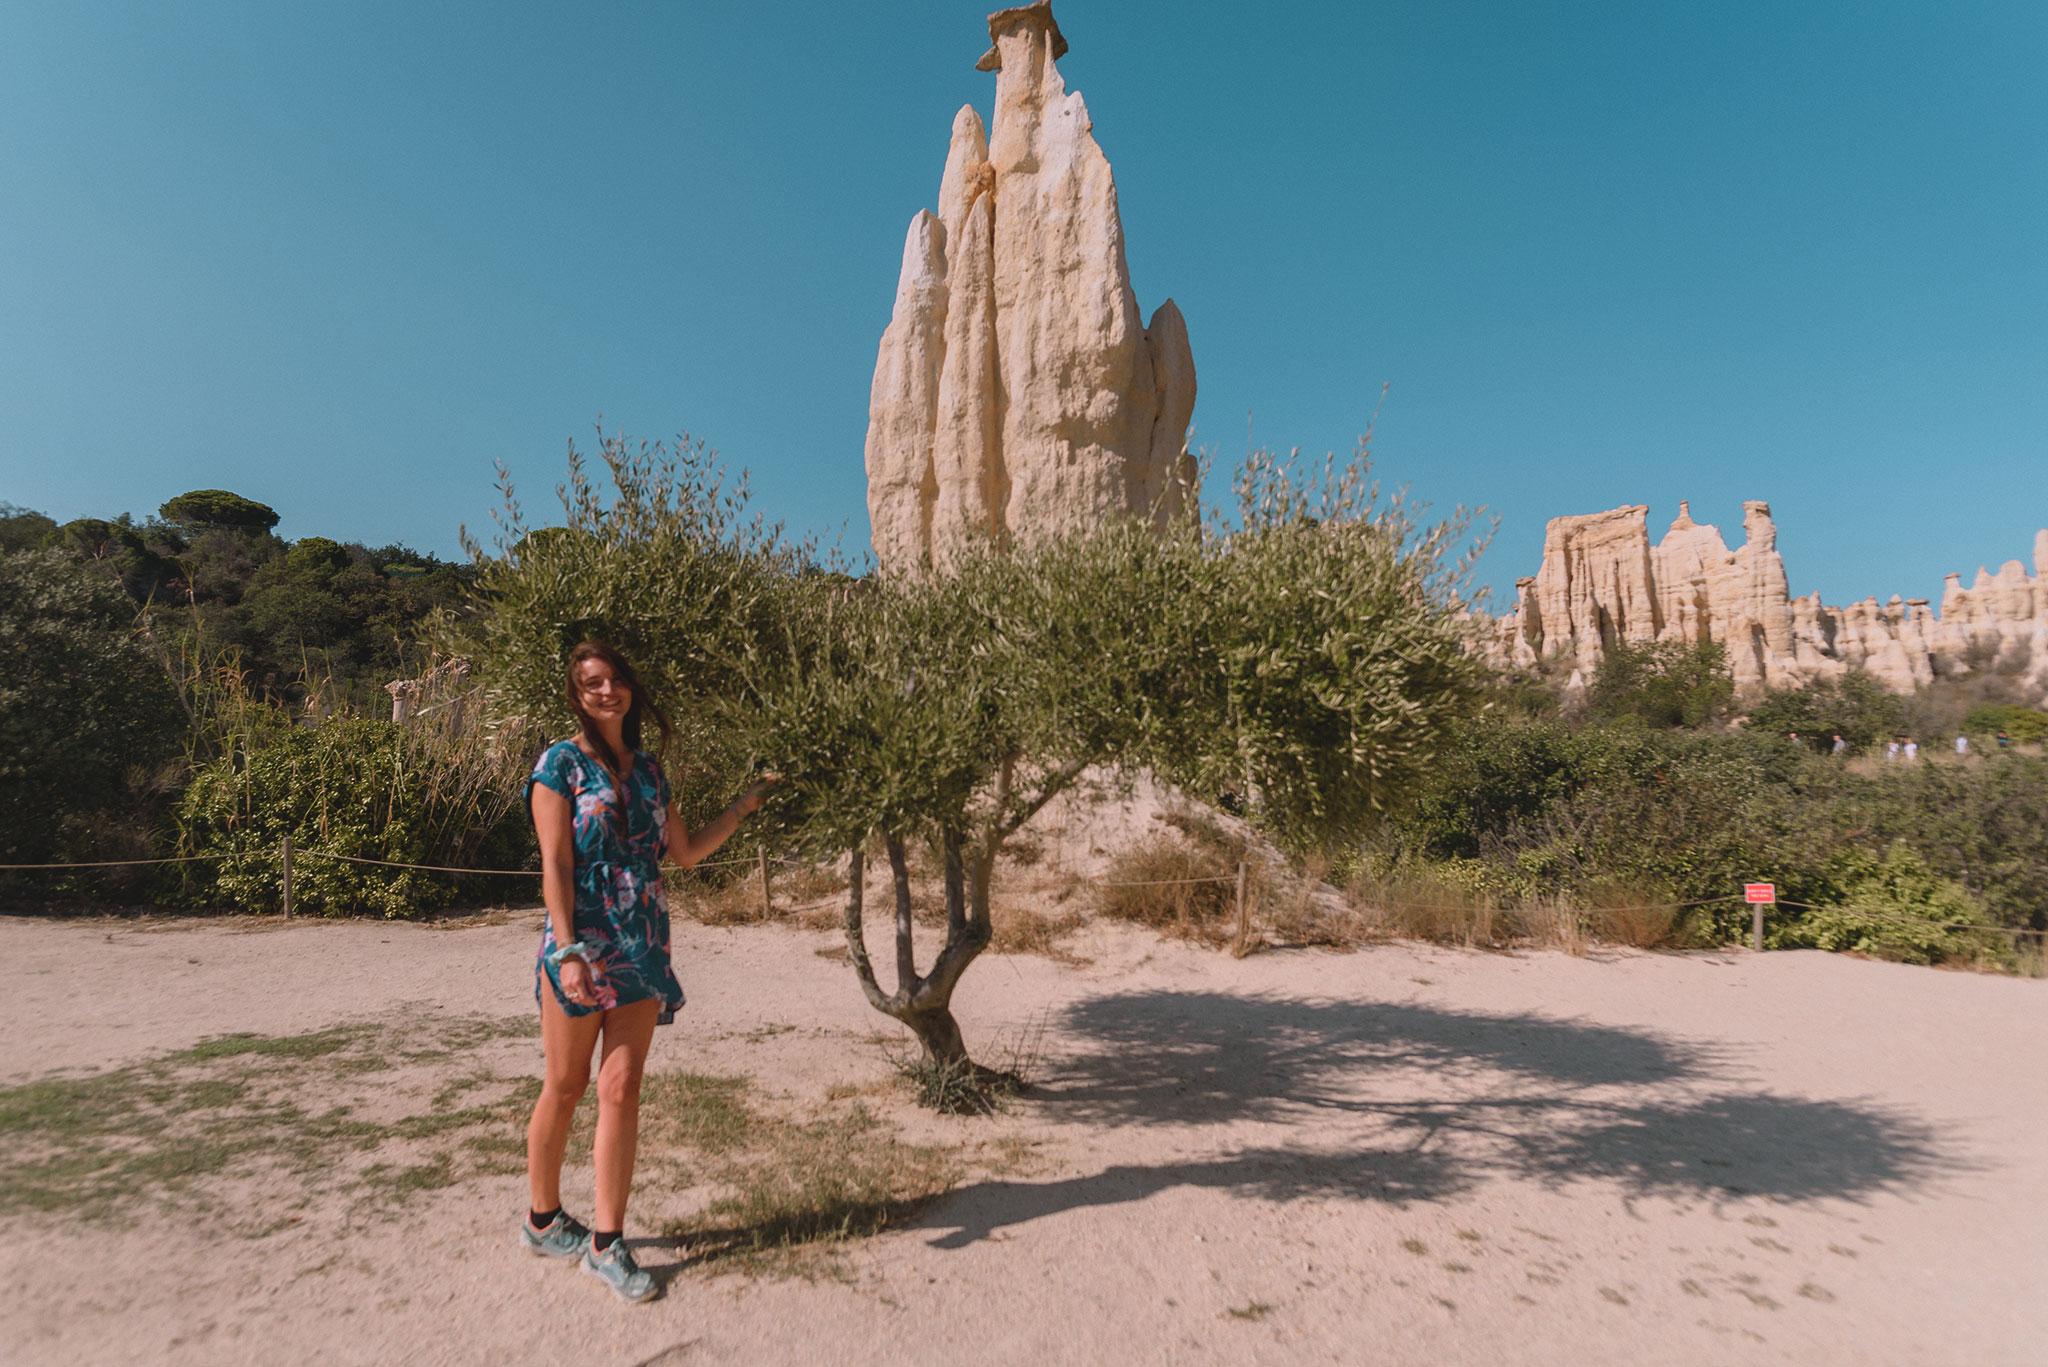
[0,0,2048,603]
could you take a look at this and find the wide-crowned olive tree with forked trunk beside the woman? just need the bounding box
[457,439,1477,1066]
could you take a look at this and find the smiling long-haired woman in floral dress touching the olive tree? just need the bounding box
[520,641,776,1301]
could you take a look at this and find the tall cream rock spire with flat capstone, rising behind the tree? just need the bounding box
[866,0,1194,570]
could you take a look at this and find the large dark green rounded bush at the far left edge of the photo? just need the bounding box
[0,551,182,889]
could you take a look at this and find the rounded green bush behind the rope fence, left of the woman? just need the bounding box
[178,717,532,916]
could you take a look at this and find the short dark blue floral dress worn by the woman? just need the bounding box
[526,740,682,1021]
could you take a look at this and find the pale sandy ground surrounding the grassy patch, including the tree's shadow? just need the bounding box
[0,918,2048,1367]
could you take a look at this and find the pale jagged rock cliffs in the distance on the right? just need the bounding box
[1491,500,2048,697]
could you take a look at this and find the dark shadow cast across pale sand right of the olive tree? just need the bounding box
[926,992,1970,1248]
